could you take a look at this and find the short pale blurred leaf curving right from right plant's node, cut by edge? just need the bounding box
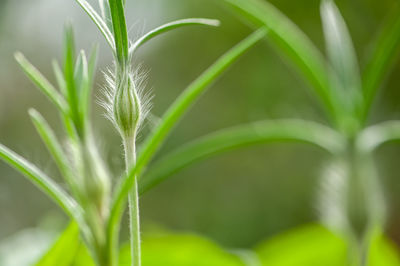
[357,121,400,152]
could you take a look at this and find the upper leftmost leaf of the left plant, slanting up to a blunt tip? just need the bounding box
[15,53,67,112]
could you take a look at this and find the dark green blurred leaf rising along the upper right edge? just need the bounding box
[363,5,400,120]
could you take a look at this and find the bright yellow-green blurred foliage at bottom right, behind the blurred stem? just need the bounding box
[256,225,400,266]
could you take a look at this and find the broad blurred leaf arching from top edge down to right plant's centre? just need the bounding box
[224,0,337,121]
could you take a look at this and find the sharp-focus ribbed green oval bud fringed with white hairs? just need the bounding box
[113,75,141,138]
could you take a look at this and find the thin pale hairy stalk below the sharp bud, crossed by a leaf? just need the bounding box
[124,137,141,266]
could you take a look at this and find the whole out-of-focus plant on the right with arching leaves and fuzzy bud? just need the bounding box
[135,0,400,265]
